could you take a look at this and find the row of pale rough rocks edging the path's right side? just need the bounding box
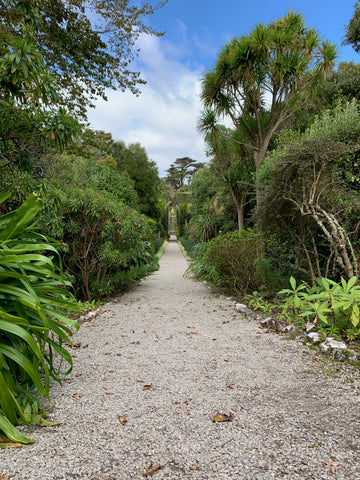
[233,302,360,367]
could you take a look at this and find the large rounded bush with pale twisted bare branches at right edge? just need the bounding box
[257,101,360,285]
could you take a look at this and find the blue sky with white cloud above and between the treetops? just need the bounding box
[89,0,360,176]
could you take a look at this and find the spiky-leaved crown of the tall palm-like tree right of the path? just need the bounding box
[198,11,337,202]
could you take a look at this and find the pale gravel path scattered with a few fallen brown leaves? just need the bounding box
[0,237,360,480]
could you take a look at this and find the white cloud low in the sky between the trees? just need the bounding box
[89,36,207,176]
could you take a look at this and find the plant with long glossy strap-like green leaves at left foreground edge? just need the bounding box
[0,195,78,443]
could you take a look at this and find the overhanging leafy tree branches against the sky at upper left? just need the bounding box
[0,0,168,117]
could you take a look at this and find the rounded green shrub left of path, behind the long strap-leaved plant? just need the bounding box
[42,188,157,301]
